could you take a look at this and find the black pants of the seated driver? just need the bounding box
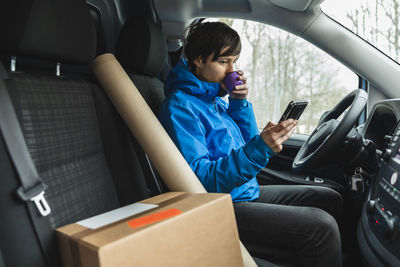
[234,185,342,267]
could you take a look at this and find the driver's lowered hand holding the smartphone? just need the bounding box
[260,119,297,153]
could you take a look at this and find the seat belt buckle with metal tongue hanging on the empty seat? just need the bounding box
[17,183,51,217]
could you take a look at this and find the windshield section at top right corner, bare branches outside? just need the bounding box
[321,0,400,62]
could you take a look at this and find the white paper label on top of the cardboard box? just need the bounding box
[77,203,158,229]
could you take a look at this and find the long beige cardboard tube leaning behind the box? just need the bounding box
[93,54,257,266]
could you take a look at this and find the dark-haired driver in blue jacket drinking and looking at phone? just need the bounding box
[159,19,342,266]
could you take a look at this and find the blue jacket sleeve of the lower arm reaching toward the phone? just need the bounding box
[159,101,274,193]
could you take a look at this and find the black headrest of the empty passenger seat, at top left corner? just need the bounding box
[0,0,96,64]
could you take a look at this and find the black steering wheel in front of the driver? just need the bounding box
[292,89,368,173]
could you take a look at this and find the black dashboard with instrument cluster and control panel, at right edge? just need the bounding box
[357,99,400,266]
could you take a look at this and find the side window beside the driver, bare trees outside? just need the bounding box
[219,19,358,134]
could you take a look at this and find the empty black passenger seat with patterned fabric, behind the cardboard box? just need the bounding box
[0,0,157,266]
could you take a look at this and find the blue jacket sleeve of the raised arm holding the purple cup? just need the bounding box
[227,98,259,142]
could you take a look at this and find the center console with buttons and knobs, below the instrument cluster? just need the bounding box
[358,124,400,266]
